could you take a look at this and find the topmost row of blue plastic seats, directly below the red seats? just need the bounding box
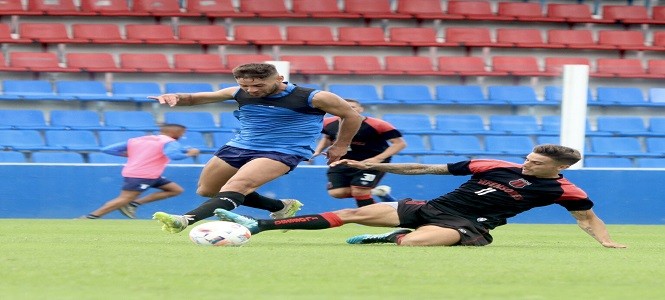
[0,80,665,106]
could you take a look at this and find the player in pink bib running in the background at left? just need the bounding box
[81,124,200,219]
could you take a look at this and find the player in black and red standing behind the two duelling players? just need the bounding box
[313,99,406,207]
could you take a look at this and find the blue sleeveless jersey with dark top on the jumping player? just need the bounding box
[227,83,325,158]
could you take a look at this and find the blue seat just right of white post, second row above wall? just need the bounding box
[585,136,648,156]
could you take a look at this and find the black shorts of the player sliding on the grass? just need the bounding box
[397,198,493,246]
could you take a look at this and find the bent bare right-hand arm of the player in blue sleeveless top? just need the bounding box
[312,91,362,164]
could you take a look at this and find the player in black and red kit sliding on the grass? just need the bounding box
[215,145,626,248]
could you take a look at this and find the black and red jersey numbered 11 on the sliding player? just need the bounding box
[430,159,593,229]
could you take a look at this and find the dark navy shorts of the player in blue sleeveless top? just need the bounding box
[215,146,307,171]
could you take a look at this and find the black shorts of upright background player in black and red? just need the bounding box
[327,165,386,190]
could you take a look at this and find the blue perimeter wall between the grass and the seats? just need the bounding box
[0,164,665,224]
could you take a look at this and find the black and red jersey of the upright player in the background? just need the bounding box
[321,117,402,162]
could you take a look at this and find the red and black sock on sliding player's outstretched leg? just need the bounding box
[258,212,344,231]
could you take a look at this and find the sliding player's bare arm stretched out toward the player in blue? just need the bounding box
[330,159,450,175]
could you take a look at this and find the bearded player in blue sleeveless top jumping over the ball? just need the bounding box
[149,63,362,233]
